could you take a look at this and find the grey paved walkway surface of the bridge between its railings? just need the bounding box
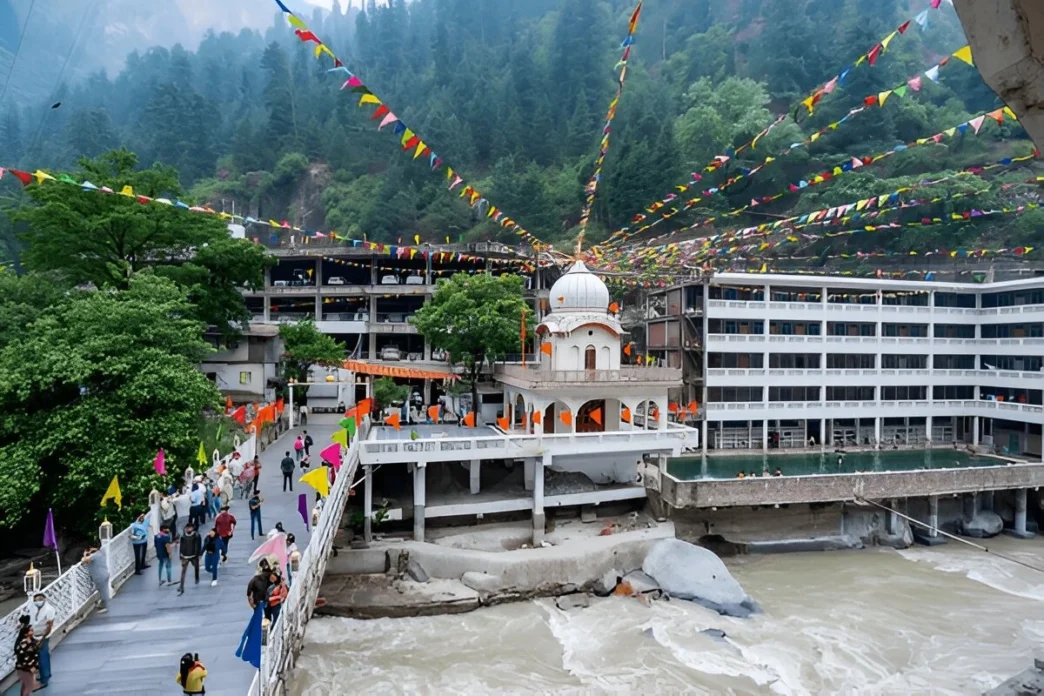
[16,425,336,696]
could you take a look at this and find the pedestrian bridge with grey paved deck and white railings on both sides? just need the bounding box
[0,424,366,696]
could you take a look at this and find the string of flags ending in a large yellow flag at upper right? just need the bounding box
[600,46,974,248]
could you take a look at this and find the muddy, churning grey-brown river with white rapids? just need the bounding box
[291,538,1044,696]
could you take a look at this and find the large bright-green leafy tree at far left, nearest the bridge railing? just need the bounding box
[0,272,219,533]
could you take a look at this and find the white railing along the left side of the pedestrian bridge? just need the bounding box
[0,437,255,693]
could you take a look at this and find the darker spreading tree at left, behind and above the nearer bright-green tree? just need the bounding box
[16,150,267,336]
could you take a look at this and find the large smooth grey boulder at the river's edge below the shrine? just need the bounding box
[642,538,760,617]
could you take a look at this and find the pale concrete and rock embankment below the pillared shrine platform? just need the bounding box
[316,523,674,619]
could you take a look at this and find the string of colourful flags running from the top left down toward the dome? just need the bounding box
[276,0,546,250]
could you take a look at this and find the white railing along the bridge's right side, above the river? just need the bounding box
[248,425,369,696]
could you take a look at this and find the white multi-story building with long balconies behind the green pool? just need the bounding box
[646,273,1044,463]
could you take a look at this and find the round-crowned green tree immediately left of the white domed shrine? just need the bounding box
[410,273,532,422]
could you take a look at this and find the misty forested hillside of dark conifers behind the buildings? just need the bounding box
[0,0,1037,260]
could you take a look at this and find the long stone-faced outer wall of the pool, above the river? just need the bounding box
[660,464,1044,507]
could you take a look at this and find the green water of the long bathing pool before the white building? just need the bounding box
[667,449,1003,481]
